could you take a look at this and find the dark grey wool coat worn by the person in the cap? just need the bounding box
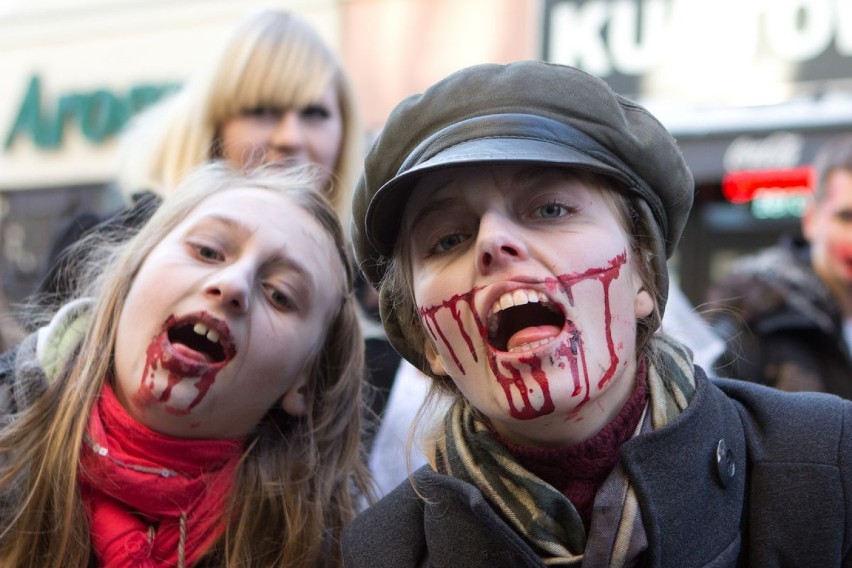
[343,369,852,568]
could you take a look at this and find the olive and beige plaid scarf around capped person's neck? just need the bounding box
[436,335,695,566]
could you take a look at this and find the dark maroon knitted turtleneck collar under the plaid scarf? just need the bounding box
[498,360,648,530]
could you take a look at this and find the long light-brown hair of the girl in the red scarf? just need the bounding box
[0,163,370,568]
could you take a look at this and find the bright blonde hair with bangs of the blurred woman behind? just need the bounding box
[118,10,364,224]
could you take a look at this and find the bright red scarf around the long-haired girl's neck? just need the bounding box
[78,384,243,568]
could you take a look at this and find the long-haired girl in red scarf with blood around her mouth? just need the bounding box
[0,163,368,567]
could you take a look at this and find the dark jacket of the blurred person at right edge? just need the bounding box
[705,241,852,400]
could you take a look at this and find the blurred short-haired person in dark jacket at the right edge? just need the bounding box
[704,135,852,400]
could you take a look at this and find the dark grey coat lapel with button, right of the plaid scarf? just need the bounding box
[622,370,747,566]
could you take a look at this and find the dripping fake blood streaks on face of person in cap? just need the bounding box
[419,252,627,420]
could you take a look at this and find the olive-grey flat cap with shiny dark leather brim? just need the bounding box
[352,61,695,364]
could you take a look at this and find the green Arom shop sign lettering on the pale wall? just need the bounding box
[4,75,176,150]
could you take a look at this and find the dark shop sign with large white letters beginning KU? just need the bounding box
[542,0,852,100]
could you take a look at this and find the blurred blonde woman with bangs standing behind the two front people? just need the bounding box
[38,9,364,303]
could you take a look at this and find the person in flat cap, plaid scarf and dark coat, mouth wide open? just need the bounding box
[344,61,852,568]
